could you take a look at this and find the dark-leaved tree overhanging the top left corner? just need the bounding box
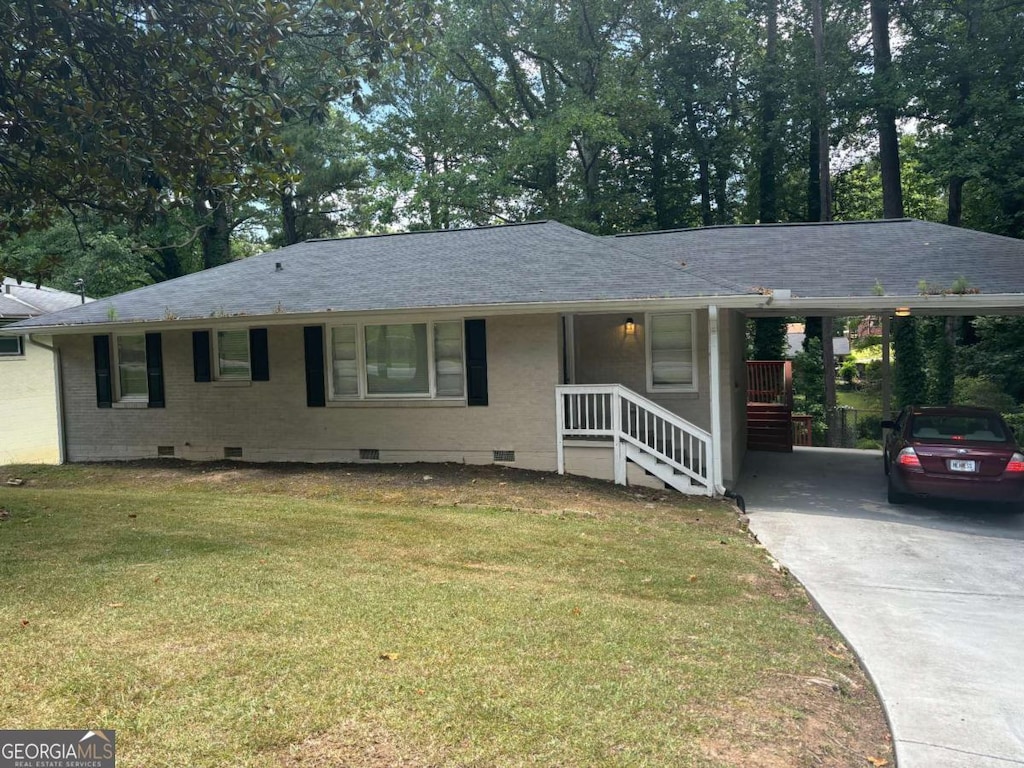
[0,0,418,266]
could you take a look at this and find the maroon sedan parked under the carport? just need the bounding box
[882,406,1024,509]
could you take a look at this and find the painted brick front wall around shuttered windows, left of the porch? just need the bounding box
[58,315,560,470]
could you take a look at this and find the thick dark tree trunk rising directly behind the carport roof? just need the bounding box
[871,0,903,219]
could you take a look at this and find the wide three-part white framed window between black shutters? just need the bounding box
[327,321,466,400]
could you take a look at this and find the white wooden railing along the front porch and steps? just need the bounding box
[555,384,715,496]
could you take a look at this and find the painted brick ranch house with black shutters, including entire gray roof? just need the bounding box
[6,220,1024,494]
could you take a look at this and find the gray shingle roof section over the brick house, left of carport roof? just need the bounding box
[9,221,748,328]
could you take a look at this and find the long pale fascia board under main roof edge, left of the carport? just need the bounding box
[14,294,768,336]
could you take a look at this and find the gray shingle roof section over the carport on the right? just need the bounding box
[615,219,1024,298]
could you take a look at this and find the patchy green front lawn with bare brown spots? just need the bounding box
[0,464,887,768]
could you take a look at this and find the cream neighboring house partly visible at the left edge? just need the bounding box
[0,278,90,465]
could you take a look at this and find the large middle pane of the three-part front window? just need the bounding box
[366,323,430,394]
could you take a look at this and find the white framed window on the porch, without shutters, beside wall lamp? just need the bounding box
[644,312,697,392]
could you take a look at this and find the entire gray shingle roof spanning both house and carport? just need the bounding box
[8,219,1024,328]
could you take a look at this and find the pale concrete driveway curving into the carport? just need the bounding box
[737,449,1024,768]
